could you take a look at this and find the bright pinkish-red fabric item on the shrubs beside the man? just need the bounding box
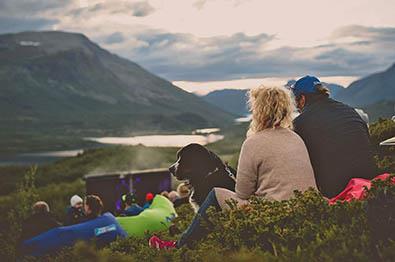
[329,174,395,205]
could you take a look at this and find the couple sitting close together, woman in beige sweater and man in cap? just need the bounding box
[149,76,377,249]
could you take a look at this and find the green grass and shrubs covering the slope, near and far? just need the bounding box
[0,120,395,261]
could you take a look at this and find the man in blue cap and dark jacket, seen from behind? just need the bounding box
[291,76,376,197]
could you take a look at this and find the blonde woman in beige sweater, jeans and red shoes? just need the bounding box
[149,87,316,249]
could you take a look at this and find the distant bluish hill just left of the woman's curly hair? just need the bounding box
[202,89,248,116]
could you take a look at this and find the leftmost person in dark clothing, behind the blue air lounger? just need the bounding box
[21,201,62,242]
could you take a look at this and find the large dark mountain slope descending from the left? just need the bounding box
[0,31,233,154]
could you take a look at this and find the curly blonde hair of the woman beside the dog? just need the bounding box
[247,86,295,135]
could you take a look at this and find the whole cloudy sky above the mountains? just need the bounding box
[0,0,395,93]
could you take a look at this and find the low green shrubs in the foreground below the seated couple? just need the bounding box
[34,175,395,261]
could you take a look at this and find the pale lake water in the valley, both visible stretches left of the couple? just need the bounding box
[0,128,224,166]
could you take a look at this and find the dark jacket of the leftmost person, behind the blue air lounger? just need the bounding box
[21,212,62,242]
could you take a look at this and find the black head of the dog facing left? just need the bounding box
[169,144,221,181]
